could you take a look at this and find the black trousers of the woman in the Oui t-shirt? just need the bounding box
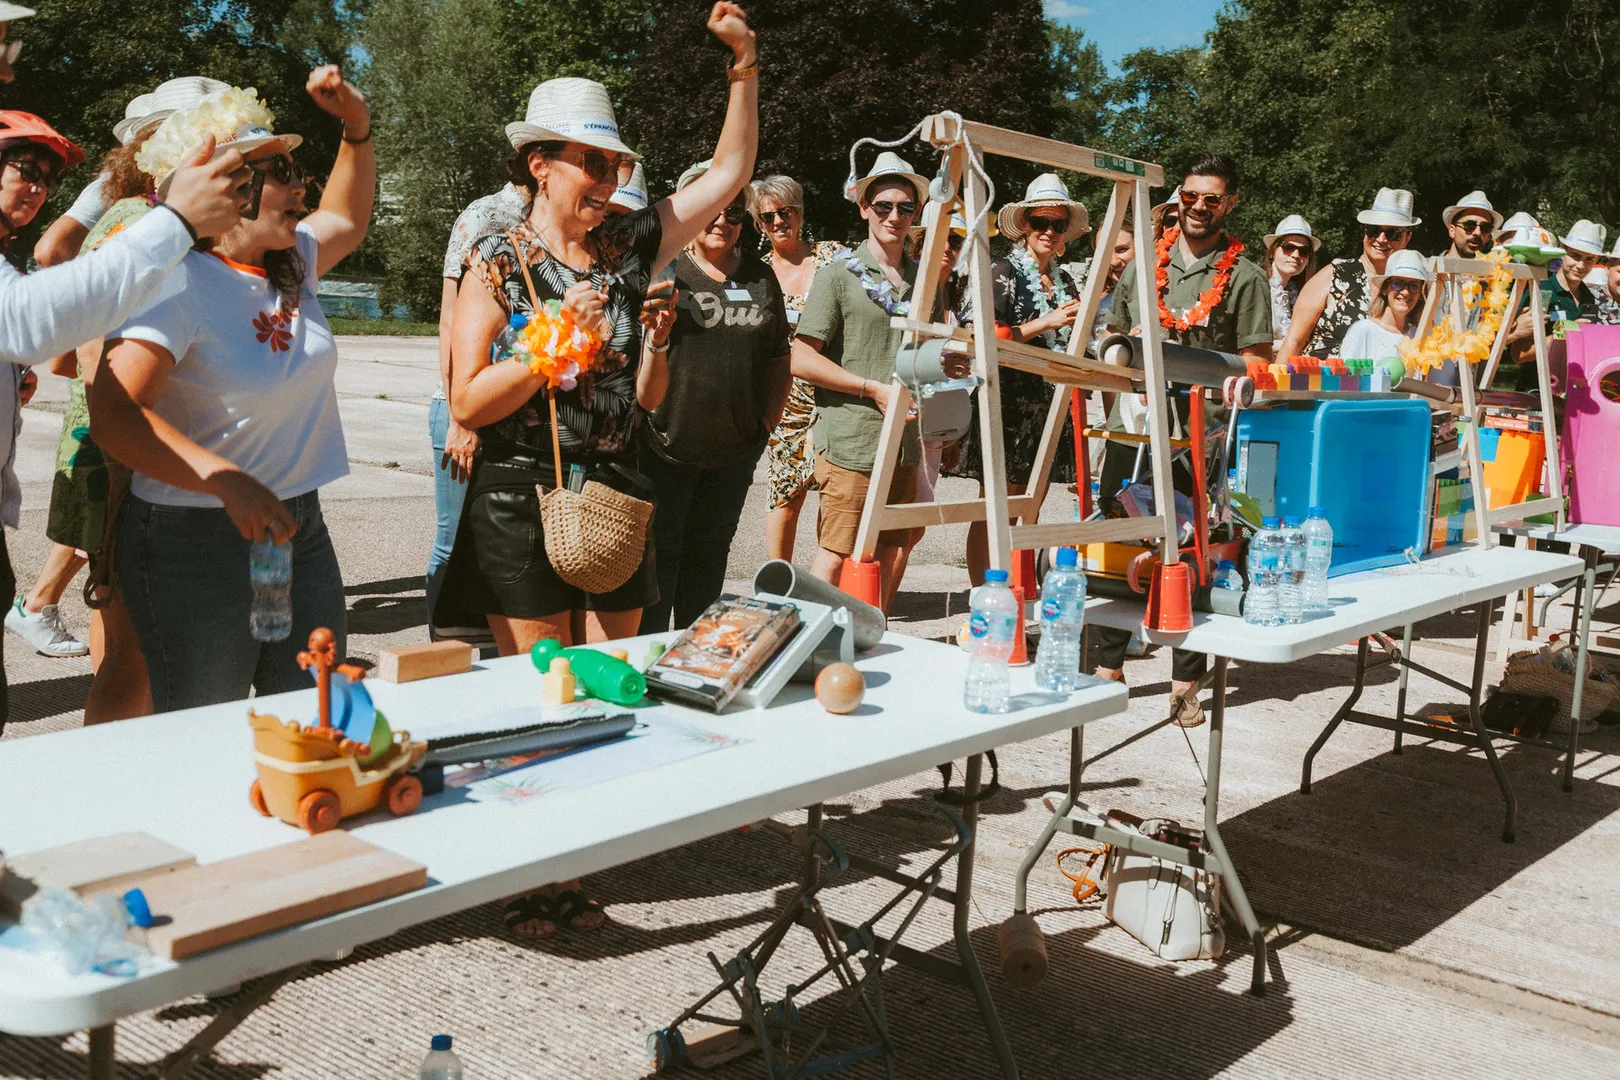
[640,449,758,633]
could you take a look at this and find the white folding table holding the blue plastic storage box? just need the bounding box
[1014,546,1584,994]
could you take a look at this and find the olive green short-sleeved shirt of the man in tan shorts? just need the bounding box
[795,243,922,473]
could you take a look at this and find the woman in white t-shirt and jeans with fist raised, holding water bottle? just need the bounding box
[91,66,376,711]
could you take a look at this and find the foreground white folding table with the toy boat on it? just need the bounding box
[0,634,1127,1080]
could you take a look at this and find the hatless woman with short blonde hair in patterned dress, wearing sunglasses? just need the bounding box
[752,173,839,562]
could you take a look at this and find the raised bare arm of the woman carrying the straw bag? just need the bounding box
[654,0,760,266]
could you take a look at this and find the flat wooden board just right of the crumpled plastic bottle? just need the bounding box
[138,831,428,960]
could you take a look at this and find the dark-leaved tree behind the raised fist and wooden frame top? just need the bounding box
[624,0,1056,247]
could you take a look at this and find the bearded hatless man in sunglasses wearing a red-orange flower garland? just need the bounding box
[1092,154,1272,727]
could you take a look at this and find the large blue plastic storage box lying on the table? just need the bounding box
[1238,398,1430,578]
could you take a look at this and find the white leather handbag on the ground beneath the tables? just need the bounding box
[1102,821,1226,960]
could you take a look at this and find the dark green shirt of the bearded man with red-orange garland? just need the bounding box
[1108,243,1272,431]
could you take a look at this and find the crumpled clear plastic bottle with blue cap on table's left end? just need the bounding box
[18,886,152,978]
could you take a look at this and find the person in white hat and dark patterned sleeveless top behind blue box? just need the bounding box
[1278,188,1422,359]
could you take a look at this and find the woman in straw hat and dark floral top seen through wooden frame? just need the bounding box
[954,173,1090,585]
